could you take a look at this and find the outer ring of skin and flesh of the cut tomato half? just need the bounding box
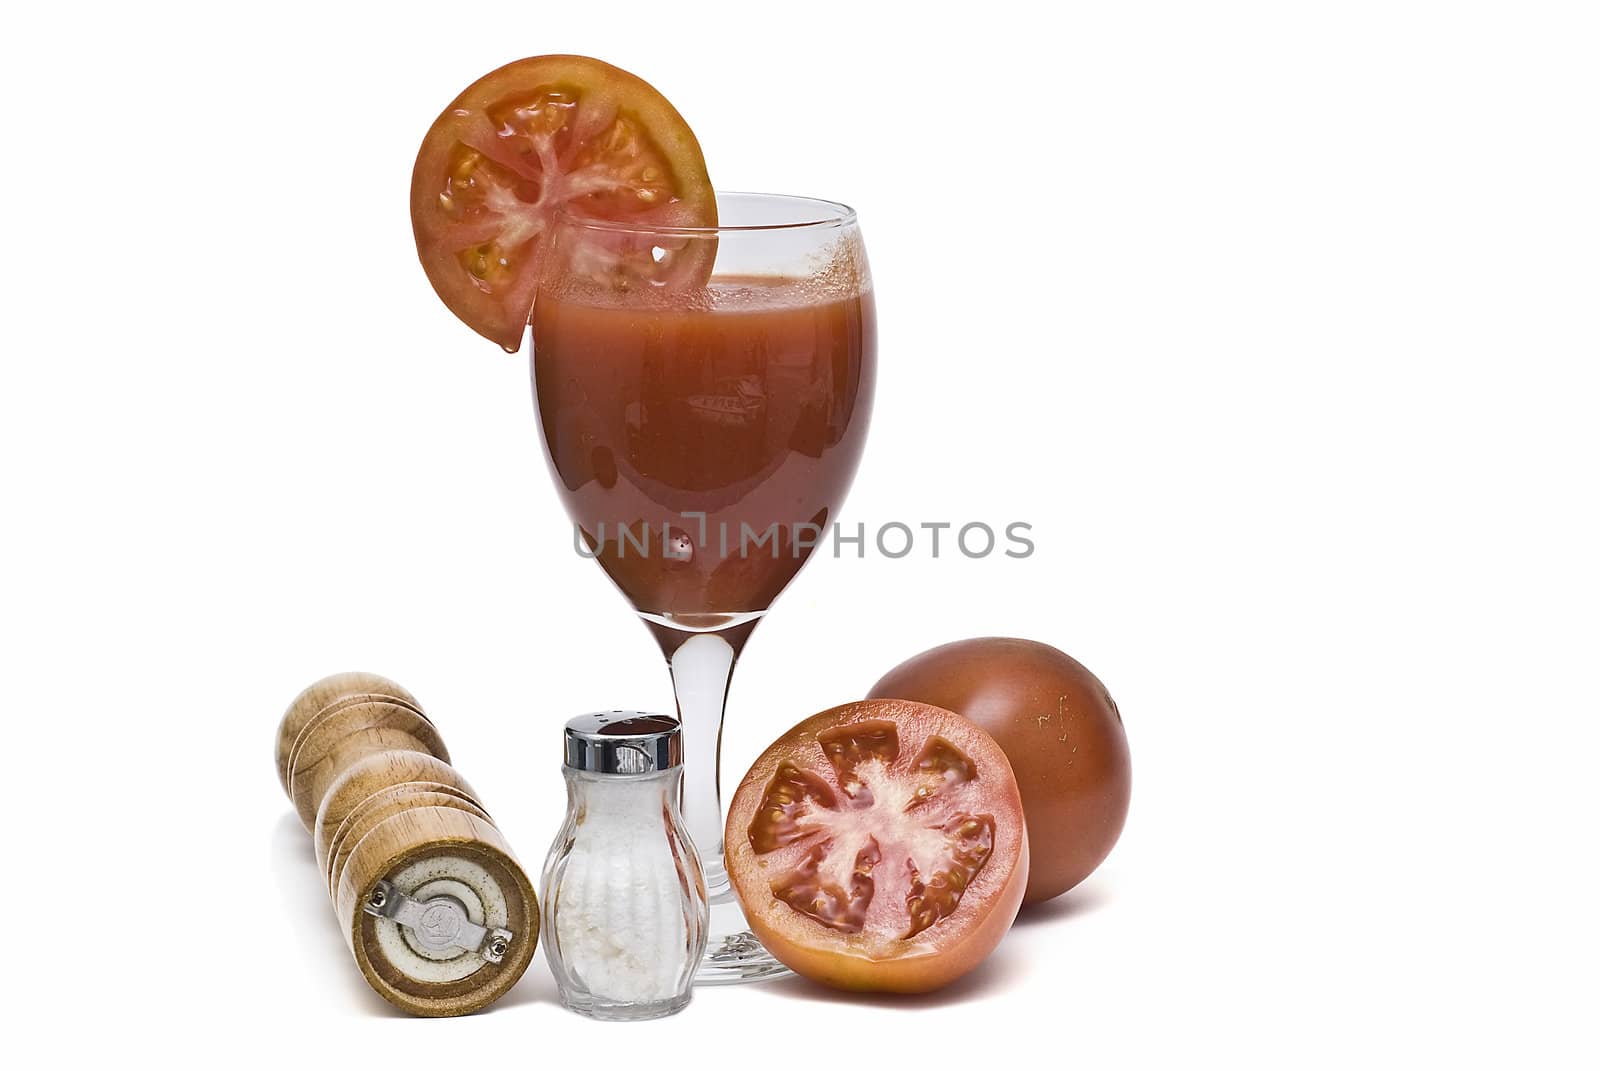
[725,700,1029,993]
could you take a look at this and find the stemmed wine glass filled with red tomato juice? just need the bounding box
[533,194,877,983]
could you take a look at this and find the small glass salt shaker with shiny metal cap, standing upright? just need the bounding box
[541,711,707,1020]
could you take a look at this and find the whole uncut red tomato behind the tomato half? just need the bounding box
[869,637,1133,905]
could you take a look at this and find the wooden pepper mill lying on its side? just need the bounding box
[277,672,539,1015]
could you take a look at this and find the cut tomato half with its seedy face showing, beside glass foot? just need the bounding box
[726,700,1029,993]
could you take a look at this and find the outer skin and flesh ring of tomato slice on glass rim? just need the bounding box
[410,56,717,352]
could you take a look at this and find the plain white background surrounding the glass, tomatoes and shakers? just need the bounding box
[0,0,1600,1068]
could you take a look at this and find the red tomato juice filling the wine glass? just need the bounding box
[533,277,877,629]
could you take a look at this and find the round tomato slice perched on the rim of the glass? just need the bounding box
[411,56,717,352]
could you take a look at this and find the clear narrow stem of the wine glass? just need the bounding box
[667,632,738,905]
